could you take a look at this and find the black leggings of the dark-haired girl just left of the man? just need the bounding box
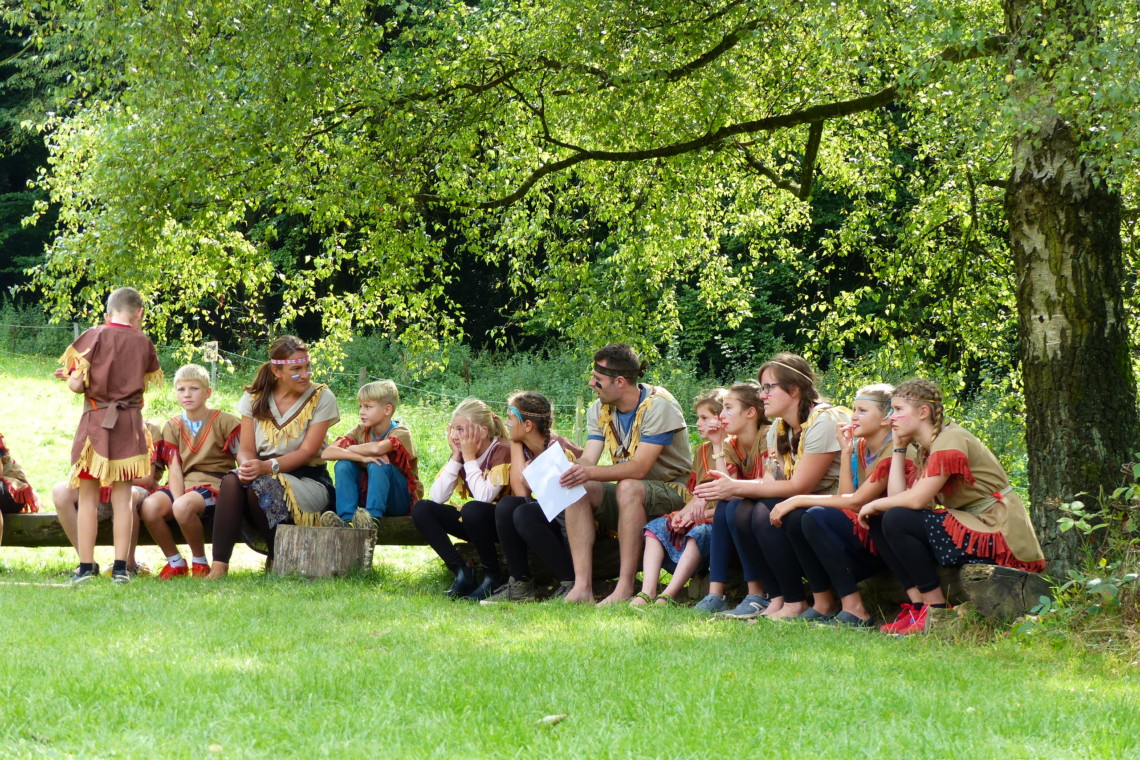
[495,496,573,582]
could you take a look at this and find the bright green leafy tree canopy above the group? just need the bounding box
[9,0,1138,366]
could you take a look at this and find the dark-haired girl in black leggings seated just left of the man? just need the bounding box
[481,391,581,604]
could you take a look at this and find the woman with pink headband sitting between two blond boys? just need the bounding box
[209,335,341,578]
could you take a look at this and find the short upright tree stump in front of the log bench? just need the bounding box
[274,524,376,578]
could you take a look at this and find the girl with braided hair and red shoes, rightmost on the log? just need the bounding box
[858,379,1045,636]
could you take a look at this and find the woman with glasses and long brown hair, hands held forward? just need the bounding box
[697,353,848,620]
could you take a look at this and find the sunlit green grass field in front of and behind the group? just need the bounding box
[0,356,1140,759]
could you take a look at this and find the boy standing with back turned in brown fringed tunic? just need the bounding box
[56,287,162,583]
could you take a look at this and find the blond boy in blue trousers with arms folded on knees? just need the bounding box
[320,381,423,528]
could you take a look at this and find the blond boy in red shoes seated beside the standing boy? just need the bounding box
[140,365,242,580]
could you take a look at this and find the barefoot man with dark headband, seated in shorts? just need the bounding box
[561,343,693,605]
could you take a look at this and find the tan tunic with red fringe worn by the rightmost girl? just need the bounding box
[919,423,1045,573]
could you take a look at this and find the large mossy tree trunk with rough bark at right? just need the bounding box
[1004,0,1137,569]
